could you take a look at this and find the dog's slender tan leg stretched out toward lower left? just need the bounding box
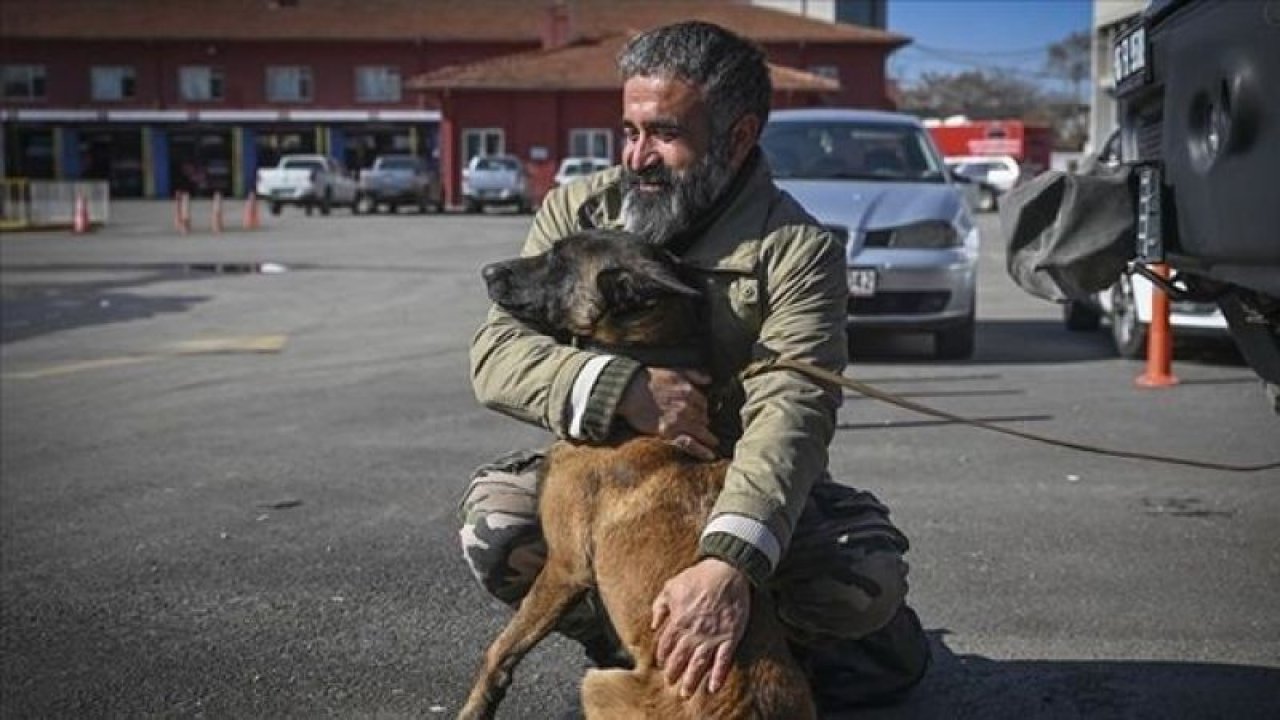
[458,562,588,720]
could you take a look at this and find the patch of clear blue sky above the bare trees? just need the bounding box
[887,0,1093,85]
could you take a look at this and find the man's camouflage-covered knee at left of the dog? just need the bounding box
[458,451,547,605]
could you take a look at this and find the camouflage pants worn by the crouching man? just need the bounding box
[460,451,929,705]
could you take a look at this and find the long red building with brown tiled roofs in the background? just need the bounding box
[0,0,908,197]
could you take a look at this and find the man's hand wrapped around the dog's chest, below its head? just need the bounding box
[618,368,719,460]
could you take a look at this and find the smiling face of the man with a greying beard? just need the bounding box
[622,76,736,242]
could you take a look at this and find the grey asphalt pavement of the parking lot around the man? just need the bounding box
[0,201,1280,719]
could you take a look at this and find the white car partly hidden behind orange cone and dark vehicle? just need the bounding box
[1062,274,1230,359]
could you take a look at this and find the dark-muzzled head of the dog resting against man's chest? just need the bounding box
[481,229,700,346]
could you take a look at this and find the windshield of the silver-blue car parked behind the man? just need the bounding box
[760,120,946,183]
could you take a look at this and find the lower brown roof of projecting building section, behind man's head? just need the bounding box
[404,33,840,92]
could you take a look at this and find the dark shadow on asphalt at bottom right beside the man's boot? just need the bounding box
[824,629,1280,720]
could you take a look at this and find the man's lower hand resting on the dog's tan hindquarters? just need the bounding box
[652,557,751,697]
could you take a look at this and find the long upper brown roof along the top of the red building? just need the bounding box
[0,0,909,47]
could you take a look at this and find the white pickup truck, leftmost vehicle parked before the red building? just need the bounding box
[256,155,360,215]
